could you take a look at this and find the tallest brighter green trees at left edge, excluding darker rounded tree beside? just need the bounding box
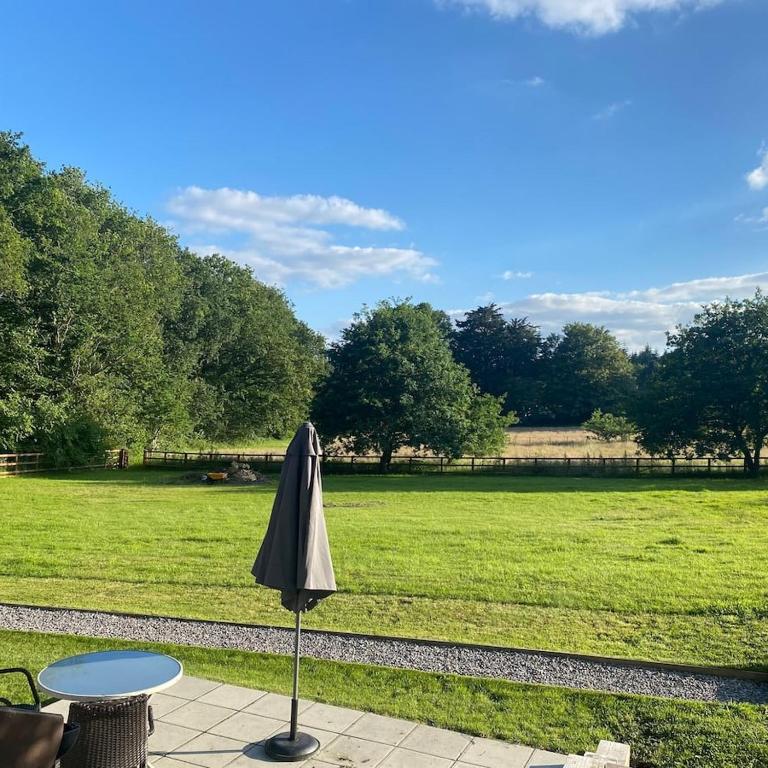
[0,134,185,453]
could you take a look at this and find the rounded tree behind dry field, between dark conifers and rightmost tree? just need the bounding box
[544,323,633,424]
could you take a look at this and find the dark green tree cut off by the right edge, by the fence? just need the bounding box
[635,291,768,474]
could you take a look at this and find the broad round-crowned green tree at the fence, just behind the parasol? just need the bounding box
[312,301,507,471]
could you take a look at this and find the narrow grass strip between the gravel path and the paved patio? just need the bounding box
[0,631,768,768]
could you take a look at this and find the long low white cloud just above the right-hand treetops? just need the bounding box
[450,272,768,350]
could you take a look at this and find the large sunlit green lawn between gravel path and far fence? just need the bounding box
[0,469,768,669]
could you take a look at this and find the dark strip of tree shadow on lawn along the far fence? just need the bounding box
[15,467,768,494]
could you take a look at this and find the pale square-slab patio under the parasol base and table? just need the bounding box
[46,677,566,768]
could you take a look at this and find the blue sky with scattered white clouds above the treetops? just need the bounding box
[0,0,768,348]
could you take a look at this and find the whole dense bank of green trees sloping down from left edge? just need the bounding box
[0,133,323,462]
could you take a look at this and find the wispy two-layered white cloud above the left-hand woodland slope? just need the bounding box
[168,187,436,288]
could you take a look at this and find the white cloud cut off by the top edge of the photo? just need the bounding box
[436,0,721,35]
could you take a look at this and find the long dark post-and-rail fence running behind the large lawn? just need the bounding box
[144,451,744,476]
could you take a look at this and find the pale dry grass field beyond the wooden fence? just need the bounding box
[183,427,638,458]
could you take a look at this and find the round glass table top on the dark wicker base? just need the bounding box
[37,651,184,701]
